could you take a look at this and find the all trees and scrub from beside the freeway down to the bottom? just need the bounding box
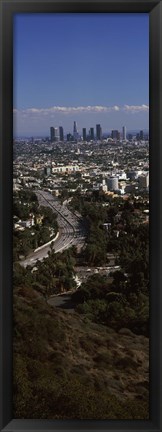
[13,197,149,419]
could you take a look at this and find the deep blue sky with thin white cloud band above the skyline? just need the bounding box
[13,14,149,136]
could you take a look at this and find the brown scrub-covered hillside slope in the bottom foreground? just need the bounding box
[14,286,149,419]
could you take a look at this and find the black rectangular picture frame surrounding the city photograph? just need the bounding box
[0,0,162,432]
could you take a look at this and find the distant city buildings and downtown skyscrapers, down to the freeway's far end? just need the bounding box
[13,121,149,198]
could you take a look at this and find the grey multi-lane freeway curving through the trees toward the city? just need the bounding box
[21,190,86,267]
